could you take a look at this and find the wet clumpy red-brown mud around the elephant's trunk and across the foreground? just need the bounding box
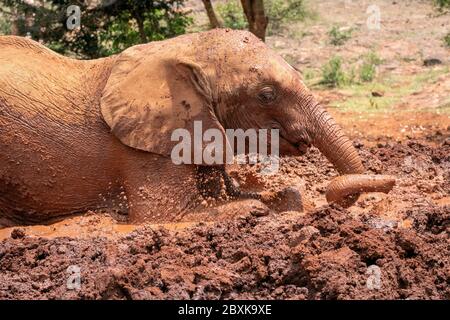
[0,132,450,299]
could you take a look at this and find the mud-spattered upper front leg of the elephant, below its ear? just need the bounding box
[123,152,201,223]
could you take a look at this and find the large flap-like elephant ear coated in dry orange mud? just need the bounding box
[100,45,227,164]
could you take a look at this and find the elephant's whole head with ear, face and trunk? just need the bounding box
[101,30,394,205]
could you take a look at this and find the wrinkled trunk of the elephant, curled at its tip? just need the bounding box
[303,96,395,206]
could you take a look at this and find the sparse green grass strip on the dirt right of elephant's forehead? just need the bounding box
[330,67,450,113]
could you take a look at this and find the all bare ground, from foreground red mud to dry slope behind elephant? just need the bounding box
[0,0,450,299]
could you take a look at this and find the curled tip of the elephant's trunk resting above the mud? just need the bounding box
[326,174,396,207]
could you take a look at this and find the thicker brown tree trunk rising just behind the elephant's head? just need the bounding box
[241,0,269,41]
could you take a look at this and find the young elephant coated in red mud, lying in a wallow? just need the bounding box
[0,30,394,225]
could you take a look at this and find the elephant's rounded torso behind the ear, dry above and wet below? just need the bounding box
[0,37,121,222]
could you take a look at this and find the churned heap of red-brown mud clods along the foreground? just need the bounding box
[0,206,450,299]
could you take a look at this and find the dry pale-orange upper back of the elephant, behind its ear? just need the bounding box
[0,36,108,124]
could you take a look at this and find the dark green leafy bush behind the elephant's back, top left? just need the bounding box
[0,0,192,58]
